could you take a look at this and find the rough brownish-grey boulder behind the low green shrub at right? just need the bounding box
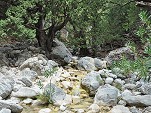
[105,47,135,64]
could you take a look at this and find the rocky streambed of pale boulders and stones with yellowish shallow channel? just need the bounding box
[0,40,151,113]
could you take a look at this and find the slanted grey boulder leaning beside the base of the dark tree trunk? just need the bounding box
[51,39,72,63]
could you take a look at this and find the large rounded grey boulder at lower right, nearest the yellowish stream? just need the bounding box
[94,84,119,106]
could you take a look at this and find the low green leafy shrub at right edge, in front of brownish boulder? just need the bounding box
[111,57,151,78]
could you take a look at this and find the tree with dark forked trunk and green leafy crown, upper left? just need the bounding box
[1,0,80,57]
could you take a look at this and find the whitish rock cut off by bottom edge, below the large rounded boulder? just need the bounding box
[110,105,132,113]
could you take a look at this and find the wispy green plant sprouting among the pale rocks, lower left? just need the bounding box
[37,68,57,104]
